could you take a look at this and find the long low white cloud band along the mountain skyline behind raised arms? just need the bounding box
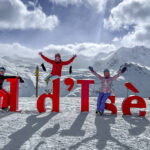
[0,43,116,58]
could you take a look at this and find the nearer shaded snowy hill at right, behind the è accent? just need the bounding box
[113,63,150,97]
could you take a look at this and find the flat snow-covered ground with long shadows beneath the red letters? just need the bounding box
[0,97,150,150]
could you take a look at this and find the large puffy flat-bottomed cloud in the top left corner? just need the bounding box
[0,0,59,30]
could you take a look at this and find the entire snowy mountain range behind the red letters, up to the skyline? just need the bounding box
[0,47,150,97]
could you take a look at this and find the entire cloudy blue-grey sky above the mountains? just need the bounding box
[0,0,150,57]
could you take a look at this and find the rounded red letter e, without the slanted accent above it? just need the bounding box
[122,96,146,116]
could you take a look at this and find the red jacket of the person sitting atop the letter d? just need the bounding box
[41,54,75,76]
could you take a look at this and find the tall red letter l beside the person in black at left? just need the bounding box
[7,78,19,111]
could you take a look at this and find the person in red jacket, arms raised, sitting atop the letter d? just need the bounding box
[39,52,77,93]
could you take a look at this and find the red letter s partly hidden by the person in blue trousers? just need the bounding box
[105,96,117,115]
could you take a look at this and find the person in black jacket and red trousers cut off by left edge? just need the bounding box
[0,67,24,110]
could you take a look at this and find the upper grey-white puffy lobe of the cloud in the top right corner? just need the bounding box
[104,0,150,30]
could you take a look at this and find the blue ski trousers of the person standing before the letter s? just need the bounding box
[97,92,111,112]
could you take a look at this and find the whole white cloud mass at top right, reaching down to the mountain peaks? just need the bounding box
[104,0,150,46]
